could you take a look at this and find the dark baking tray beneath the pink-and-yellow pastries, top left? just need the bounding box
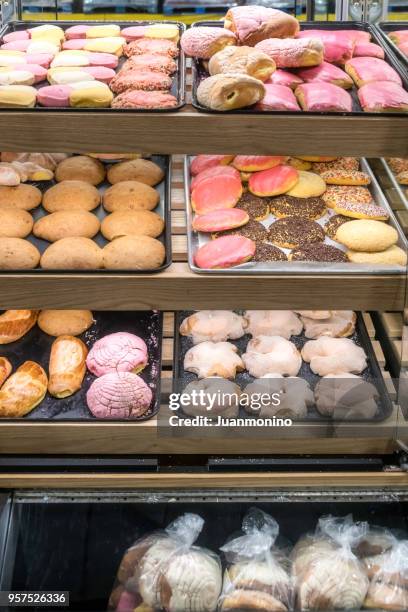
[0,20,186,113]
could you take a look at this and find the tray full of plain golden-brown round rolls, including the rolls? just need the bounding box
[0,153,171,274]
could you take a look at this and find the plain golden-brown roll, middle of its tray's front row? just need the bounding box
[40,237,102,270]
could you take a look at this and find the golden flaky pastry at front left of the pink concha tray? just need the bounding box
[0,361,48,418]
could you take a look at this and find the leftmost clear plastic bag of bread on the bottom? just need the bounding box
[109,513,222,612]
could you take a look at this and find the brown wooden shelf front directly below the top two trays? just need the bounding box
[0,110,408,157]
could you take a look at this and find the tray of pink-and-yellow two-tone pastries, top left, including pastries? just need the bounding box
[0,20,185,112]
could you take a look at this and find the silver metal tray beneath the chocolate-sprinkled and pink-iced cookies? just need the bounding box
[184,157,408,275]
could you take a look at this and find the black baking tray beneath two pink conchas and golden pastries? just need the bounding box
[0,311,163,423]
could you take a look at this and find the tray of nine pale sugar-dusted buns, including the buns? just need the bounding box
[173,310,392,422]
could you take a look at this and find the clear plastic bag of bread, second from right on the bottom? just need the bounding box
[292,515,369,610]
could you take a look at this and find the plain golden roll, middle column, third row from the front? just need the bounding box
[43,181,101,212]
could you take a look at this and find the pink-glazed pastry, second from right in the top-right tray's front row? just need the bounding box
[295,82,353,113]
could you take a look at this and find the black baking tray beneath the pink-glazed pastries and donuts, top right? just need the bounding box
[192,21,408,117]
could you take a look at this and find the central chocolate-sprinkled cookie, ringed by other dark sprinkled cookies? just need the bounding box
[268,217,324,249]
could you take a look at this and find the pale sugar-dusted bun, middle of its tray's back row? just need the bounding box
[243,310,303,340]
